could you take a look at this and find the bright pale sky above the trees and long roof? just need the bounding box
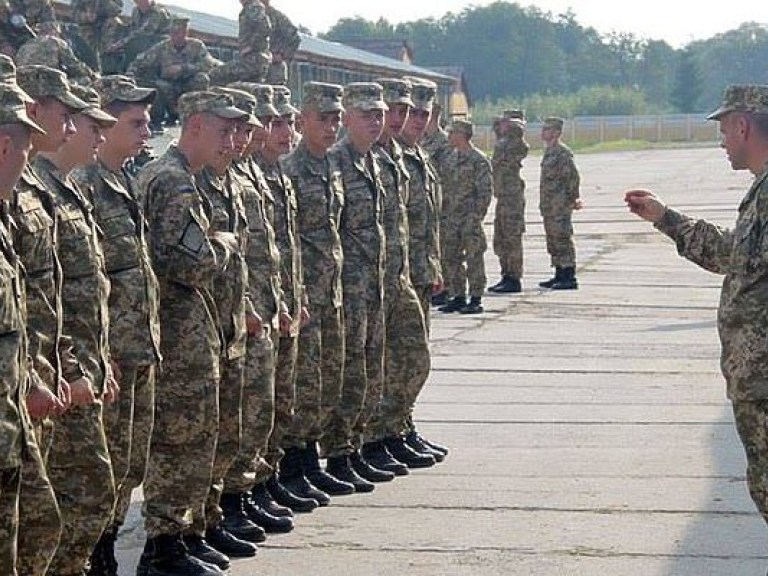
[163,0,768,48]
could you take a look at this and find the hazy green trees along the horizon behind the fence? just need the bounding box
[323,2,768,118]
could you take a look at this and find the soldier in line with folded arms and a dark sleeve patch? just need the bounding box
[138,92,247,576]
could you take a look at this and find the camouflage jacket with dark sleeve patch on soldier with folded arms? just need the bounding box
[138,144,230,379]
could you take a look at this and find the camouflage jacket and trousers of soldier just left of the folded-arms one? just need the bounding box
[73,162,160,526]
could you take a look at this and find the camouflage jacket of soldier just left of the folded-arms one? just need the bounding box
[72,162,160,366]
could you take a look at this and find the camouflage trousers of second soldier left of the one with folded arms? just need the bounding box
[48,401,115,576]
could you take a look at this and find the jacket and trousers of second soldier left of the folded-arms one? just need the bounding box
[34,157,115,574]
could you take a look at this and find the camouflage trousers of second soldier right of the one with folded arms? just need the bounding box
[224,330,279,494]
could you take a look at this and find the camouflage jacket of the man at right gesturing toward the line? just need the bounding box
[656,166,768,402]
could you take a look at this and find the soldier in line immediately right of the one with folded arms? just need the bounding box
[193,88,265,558]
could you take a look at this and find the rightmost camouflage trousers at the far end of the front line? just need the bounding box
[365,285,430,442]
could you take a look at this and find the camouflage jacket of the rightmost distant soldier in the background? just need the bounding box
[539,143,579,217]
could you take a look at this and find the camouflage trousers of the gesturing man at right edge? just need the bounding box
[733,400,768,522]
